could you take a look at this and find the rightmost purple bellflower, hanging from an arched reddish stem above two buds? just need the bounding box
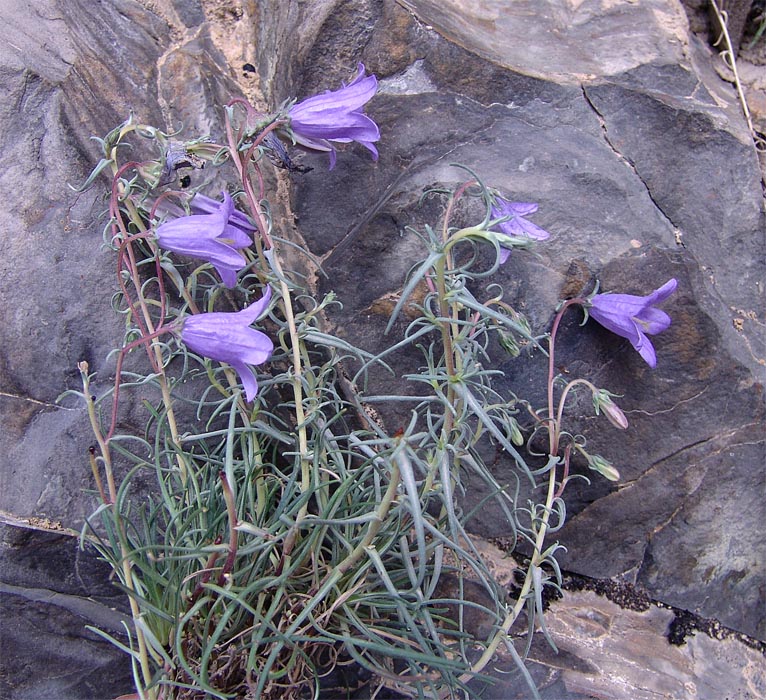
[588,279,678,368]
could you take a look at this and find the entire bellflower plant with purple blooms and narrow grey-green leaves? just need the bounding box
[67,64,675,700]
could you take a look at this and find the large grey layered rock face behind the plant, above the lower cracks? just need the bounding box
[0,0,766,697]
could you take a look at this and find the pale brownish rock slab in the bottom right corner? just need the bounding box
[528,591,766,700]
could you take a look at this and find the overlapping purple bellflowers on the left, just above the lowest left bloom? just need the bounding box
[156,192,255,288]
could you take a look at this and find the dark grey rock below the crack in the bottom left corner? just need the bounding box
[0,515,133,700]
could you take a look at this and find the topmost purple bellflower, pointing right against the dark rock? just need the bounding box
[288,63,380,170]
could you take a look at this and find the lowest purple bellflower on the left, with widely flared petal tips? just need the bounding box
[181,287,274,401]
